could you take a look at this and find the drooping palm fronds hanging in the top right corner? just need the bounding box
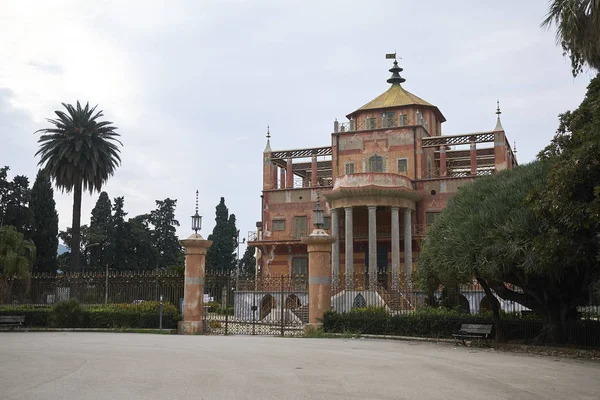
[542,0,600,76]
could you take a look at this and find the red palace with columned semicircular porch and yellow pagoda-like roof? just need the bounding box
[249,61,517,290]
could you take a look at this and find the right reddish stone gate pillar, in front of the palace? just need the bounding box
[302,229,335,327]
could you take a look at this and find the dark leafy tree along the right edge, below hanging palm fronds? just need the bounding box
[529,75,600,335]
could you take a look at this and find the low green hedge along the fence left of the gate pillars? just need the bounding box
[0,300,181,329]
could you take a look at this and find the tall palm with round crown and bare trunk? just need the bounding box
[35,101,123,271]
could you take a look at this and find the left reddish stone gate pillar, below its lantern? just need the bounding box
[178,233,212,335]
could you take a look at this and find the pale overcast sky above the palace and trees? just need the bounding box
[0,0,592,250]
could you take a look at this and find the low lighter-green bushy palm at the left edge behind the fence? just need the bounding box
[0,225,35,302]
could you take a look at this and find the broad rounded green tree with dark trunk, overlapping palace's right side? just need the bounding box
[418,162,588,342]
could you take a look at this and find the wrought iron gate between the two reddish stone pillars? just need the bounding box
[204,274,308,336]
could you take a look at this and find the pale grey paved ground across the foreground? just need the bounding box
[0,332,600,400]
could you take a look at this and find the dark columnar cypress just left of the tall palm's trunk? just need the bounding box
[29,170,58,273]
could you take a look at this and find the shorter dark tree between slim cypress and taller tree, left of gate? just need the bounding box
[125,214,157,270]
